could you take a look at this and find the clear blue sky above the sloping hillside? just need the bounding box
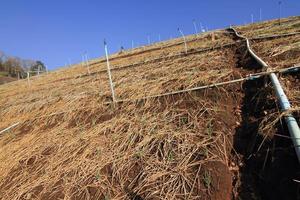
[0,0,300,69]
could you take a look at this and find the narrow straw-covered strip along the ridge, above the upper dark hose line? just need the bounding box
[85,30,234,70]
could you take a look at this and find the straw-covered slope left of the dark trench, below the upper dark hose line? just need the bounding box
[0,24,247,199]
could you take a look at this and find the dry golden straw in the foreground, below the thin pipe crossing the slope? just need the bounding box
[0,90,240,199]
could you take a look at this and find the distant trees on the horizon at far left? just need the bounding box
[0,51,46,78]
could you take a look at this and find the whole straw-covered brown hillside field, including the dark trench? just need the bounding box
[0,17,300,200]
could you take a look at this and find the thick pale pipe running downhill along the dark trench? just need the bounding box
[231,28,300,162]
